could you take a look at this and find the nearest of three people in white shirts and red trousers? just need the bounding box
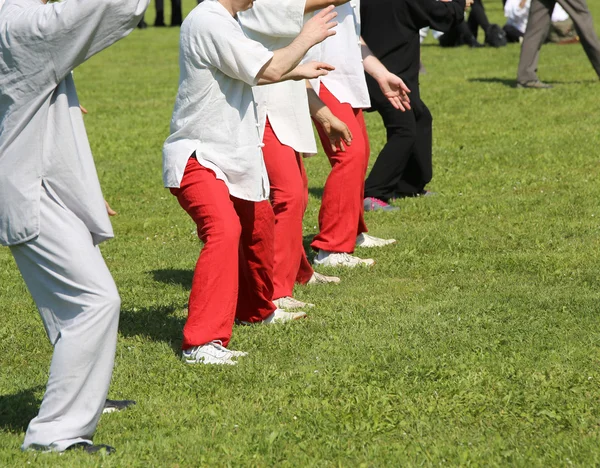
[163,0,335,364]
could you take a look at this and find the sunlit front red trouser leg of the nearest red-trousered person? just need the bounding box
[171,158,241,349]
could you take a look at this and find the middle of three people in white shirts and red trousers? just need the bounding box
[239,0,349,309]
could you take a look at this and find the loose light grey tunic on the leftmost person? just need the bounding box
[0,0,149,245]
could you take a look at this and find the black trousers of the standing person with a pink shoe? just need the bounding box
[365,77,433,201]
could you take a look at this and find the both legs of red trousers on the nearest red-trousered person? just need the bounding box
[171,157,275,349]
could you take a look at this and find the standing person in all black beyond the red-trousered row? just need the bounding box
[361,0,472,203]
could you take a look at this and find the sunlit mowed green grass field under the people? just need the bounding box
[0,0,600,467]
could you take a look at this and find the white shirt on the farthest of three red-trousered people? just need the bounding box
[306,0,371,109]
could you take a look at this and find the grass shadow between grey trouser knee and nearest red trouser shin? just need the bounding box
[119,306,185,354]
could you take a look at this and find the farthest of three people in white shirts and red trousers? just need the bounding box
[308,0,409,267]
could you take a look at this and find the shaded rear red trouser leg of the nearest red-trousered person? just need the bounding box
[231,197,276,323]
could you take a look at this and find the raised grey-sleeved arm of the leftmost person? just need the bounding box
[11,0,149,83]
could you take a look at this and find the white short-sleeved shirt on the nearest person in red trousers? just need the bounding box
[163,0,273,201]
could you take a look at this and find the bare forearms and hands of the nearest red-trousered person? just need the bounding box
[257,6,337,85]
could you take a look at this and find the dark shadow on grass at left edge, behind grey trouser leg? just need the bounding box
[0,385,44,433]
